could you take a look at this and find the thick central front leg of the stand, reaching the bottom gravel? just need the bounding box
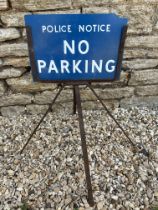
[74,85,94,206]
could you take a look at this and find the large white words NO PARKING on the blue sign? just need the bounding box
[37,40,116,74]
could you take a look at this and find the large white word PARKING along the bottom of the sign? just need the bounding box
[37,59,116,74]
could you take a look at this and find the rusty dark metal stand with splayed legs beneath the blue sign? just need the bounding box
[20,82,149,206]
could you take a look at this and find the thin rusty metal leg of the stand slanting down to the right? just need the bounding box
[88,84,149,157]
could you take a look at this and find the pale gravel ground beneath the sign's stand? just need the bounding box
[0,107,158,210]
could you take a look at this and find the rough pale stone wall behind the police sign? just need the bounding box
[0,0,158,116]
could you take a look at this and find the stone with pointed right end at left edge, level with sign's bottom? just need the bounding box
[0,68,26,79]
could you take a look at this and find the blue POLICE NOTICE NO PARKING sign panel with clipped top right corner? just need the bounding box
[25,14,128,82]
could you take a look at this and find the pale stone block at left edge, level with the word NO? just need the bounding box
[0,43,28,57]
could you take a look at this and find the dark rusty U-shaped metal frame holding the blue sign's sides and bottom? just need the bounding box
[26,14,128,84]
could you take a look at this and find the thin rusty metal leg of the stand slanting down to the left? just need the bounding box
[20,87,63,154]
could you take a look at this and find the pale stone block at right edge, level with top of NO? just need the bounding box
[125,35,158,48]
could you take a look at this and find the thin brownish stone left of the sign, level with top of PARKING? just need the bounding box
[3,57,30,67]
